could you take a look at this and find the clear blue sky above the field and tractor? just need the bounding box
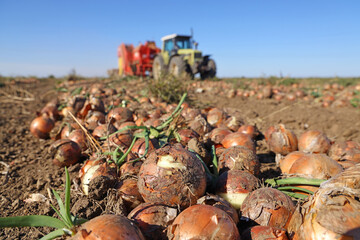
[0,0,360,77]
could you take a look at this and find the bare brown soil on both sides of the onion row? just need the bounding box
[0,80,360,239]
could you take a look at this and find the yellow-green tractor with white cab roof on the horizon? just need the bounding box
[152,34,216,79]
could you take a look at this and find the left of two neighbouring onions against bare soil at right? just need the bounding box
[267,124,298,155]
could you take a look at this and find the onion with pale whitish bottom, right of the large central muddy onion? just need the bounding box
[215,170,259,209]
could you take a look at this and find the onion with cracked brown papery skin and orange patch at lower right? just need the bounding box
[241,188,295,228]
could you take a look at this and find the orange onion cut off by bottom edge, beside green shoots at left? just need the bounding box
[72,214,145,240]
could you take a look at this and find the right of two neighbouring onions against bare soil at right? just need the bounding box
[299,130,331,153]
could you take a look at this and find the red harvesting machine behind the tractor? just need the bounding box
[118,41,161,77]
